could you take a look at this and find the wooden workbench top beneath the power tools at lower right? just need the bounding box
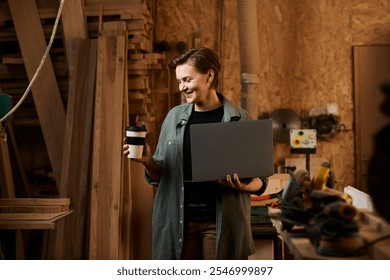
[269,208,390,260]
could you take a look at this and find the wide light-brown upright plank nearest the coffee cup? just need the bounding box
[89,22,127,259]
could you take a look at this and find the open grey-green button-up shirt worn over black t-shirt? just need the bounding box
[145,94,268,260]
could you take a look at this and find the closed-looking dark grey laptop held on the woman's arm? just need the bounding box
[190,119,274,182]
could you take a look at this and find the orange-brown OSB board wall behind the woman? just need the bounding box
[155,0,390,188]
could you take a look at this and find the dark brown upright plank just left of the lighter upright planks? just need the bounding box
[52,39,97,259]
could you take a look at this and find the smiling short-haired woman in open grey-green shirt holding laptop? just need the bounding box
[124,48,268,259]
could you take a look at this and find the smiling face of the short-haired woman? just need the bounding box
[176,63,214,107]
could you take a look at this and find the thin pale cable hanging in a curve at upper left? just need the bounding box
[0,0,65,123]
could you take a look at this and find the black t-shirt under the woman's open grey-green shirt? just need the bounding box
[183,106,223,221]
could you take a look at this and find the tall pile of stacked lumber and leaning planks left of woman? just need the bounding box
[0,0,168,259]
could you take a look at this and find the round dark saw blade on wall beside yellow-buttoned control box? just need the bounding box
[270,109,301,143]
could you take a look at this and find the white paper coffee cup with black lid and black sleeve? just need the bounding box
[126,126,147,159]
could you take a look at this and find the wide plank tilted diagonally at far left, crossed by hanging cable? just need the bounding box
[8,0,65,185]
